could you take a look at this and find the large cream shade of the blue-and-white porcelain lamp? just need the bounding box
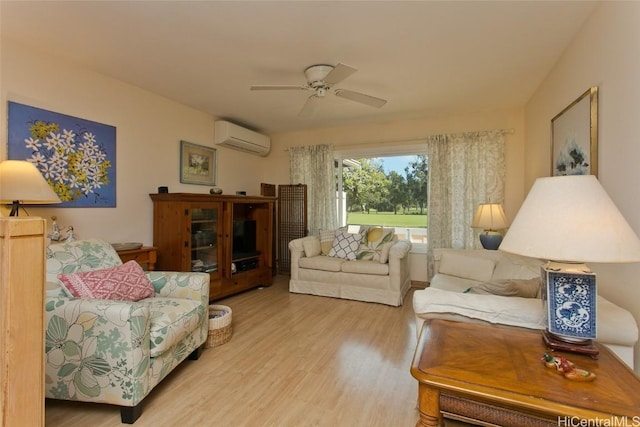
[500,175,640,263]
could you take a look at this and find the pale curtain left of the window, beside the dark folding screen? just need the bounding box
[289,145,338,235]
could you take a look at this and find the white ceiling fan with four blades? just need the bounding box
[251,64,387,116]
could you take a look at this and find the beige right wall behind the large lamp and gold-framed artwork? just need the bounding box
[525,2,640,373]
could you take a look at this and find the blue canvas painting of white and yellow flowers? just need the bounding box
[8,102,116,208]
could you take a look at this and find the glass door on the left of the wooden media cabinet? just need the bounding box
[191,205,220,275]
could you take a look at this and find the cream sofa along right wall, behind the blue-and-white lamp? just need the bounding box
[413,249,638,368]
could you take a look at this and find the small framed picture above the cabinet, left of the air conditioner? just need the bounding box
[180,141,217,185]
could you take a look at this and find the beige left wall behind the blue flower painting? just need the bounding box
[0,38,267,244]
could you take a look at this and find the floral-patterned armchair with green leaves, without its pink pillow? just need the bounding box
[45,239,209,424]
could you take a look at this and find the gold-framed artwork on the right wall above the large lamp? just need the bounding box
[551,86,598,176]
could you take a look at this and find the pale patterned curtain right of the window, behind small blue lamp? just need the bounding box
[427,131,505,272]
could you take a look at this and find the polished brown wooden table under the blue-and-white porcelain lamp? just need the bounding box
[411,320,640,427]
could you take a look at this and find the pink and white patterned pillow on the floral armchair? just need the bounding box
[58,261,155,301]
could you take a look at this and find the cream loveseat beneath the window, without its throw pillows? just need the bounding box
[289,236,411,306]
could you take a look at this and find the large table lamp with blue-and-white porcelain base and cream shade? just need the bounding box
[500,175,640,356]
